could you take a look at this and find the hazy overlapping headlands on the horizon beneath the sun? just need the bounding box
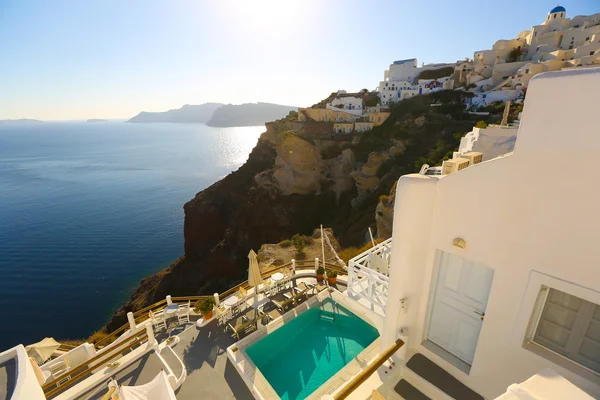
[126,103,298,127]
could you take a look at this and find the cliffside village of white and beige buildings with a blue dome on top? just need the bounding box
[298,6,600,174]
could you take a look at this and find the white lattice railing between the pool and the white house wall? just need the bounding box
[348,239,392,316]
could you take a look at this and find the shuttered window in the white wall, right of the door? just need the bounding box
[533,288,600,373]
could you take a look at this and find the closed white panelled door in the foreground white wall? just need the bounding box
[427,252,494,365]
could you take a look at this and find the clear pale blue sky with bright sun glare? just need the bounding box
[0,0,600,120]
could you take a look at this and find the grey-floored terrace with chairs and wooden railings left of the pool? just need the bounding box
[15,260,347,400]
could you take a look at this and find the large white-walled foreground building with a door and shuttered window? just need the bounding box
[349,68,600,400]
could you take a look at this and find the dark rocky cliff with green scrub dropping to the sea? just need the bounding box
[107,92,473,330]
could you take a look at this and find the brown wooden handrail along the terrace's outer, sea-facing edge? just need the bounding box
[94,260,347,347]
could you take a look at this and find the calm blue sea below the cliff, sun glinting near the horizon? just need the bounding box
[0,122,264,350]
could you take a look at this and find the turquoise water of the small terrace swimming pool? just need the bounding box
[246,300,379,400]
